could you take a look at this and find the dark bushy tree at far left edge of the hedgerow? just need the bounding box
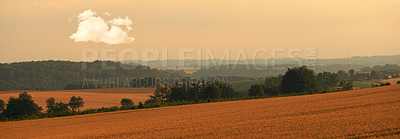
[3,92,42,118]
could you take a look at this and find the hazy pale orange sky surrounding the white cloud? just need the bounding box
[0,0,400,62]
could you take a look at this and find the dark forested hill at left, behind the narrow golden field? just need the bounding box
[0,61,180,90]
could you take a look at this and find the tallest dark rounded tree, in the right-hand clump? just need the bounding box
[281,66,318,93]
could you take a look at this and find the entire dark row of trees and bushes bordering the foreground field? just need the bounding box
[0,67,364,121]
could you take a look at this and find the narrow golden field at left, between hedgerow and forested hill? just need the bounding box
[0,88,154,110]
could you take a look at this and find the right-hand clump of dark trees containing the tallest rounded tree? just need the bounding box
[248,66,353,96]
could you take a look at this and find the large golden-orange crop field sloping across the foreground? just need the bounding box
[0,85,400,138]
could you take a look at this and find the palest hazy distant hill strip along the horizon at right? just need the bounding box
[121,55,400,68]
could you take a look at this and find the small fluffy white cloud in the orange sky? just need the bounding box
[69,9,135,45]
